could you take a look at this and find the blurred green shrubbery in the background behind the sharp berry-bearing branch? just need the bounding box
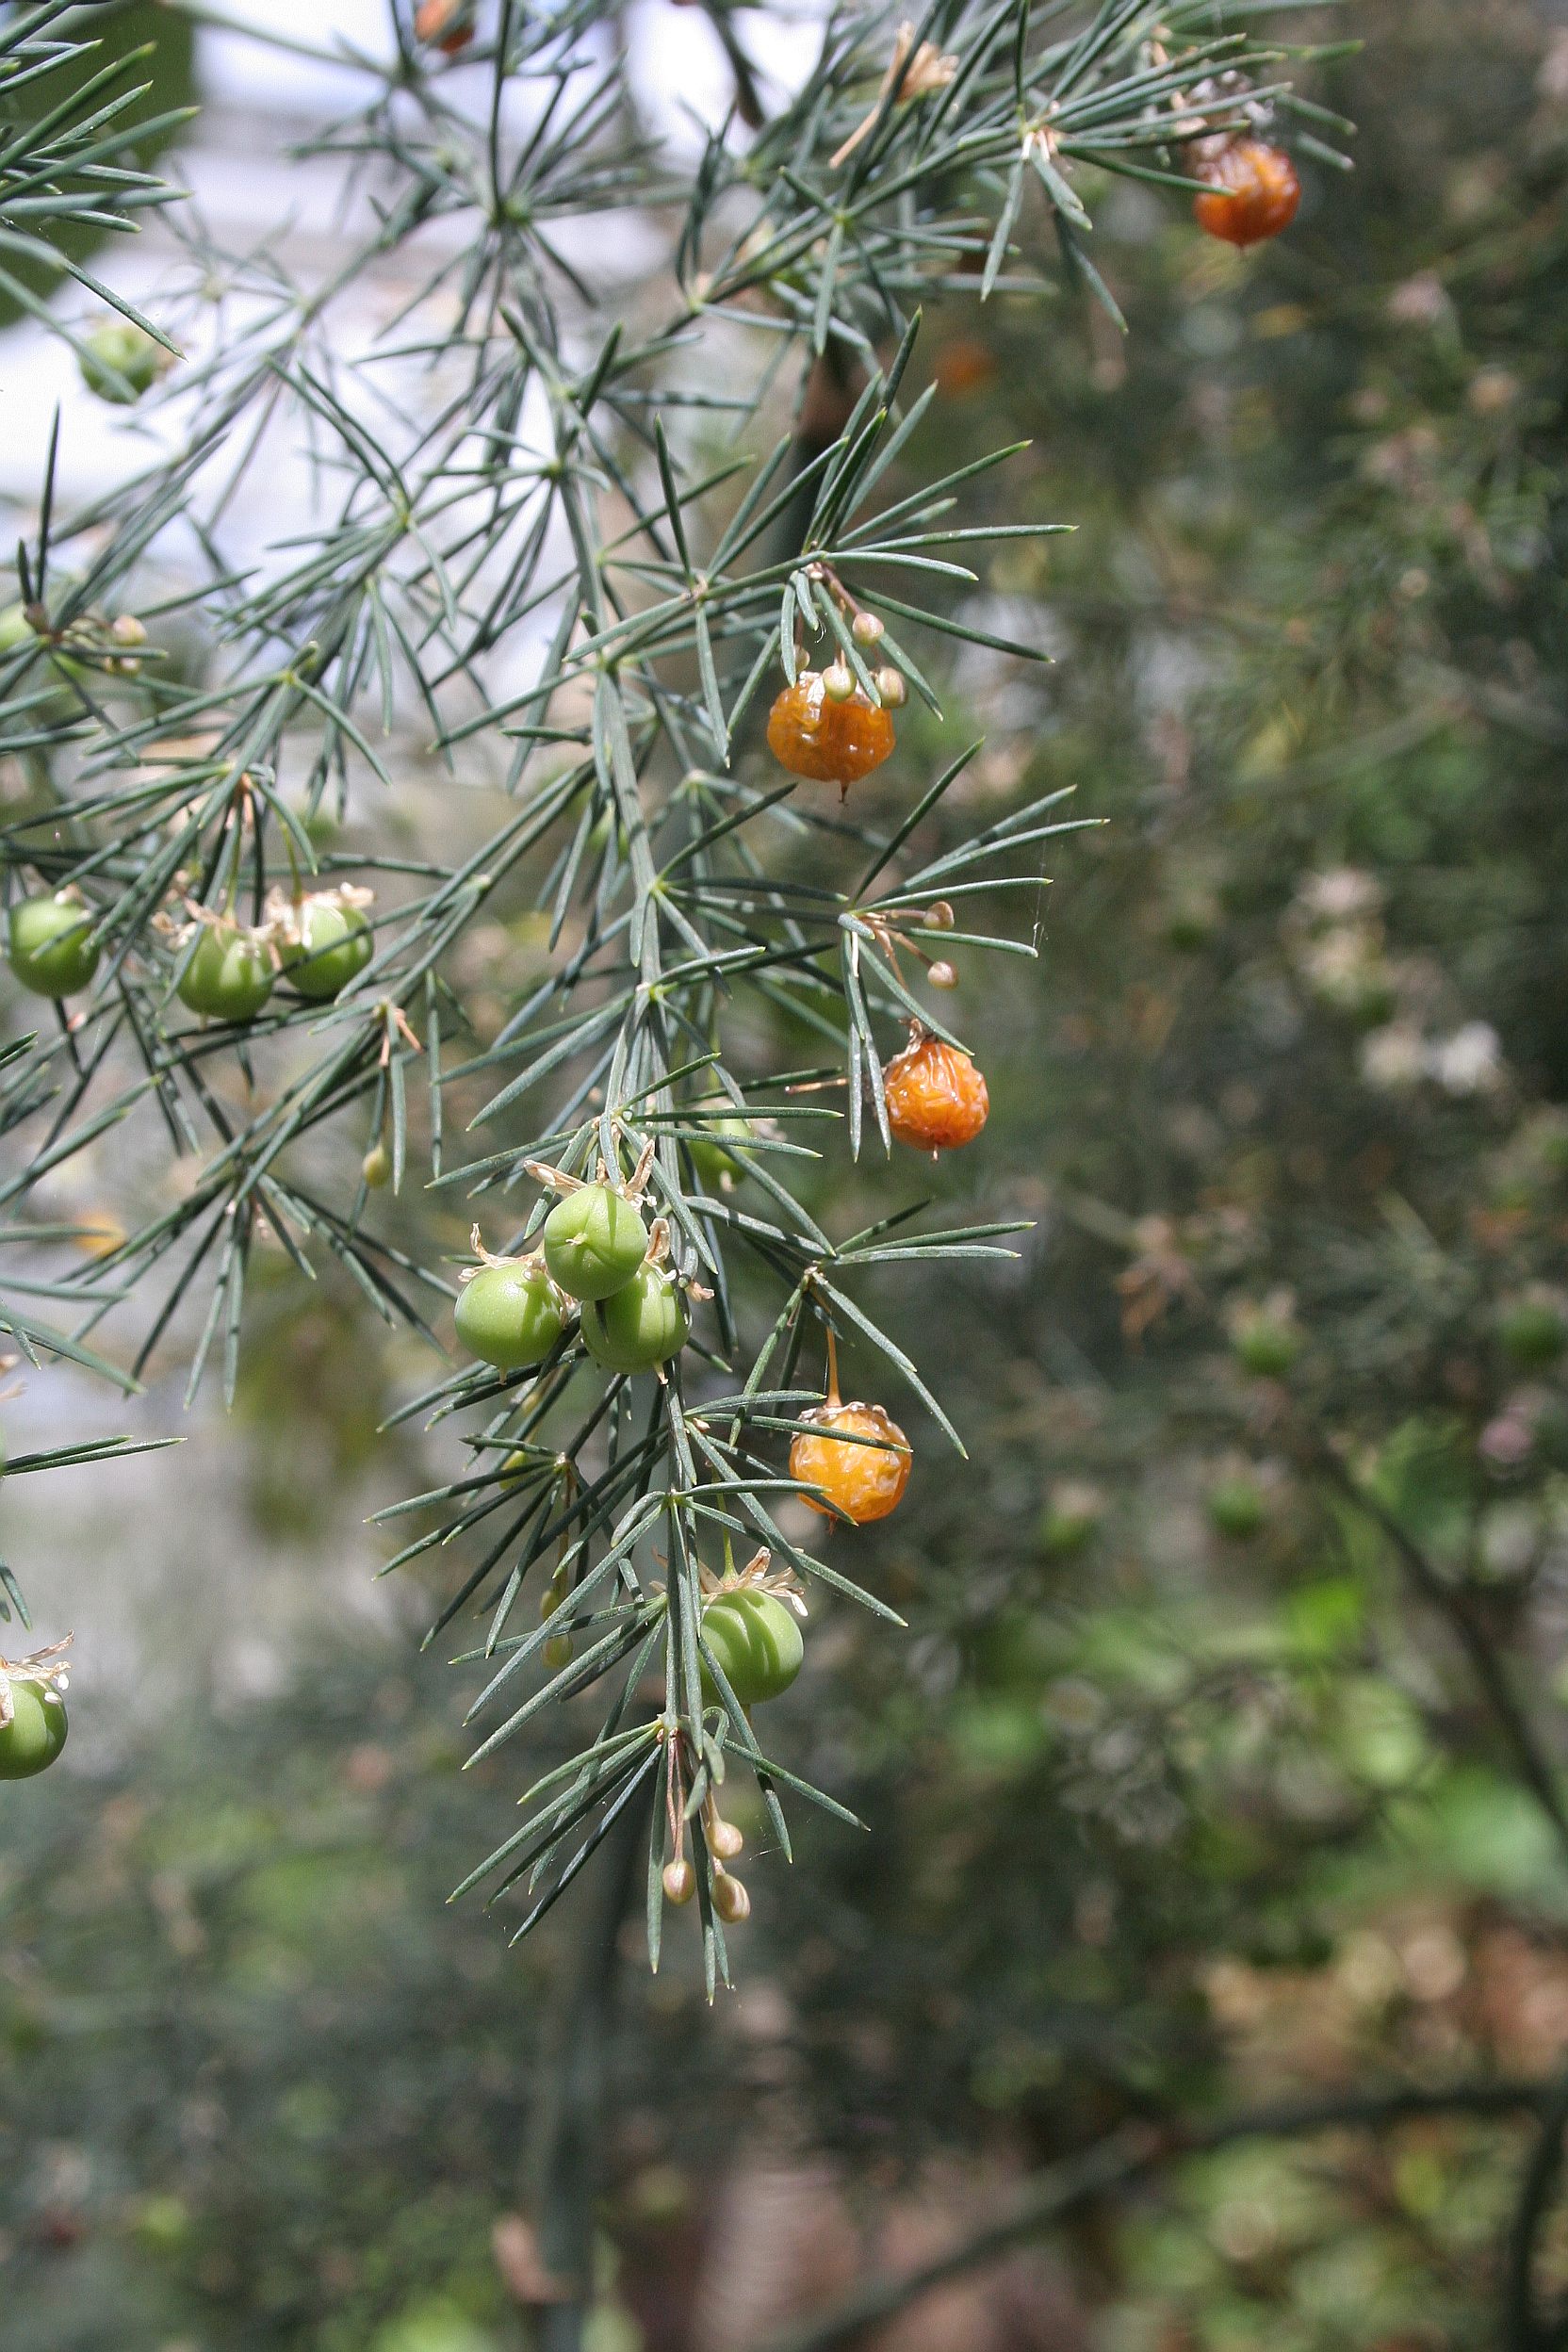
[0,0,1568,2352]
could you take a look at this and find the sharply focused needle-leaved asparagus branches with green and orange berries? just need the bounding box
[0,0,1338,1987]
